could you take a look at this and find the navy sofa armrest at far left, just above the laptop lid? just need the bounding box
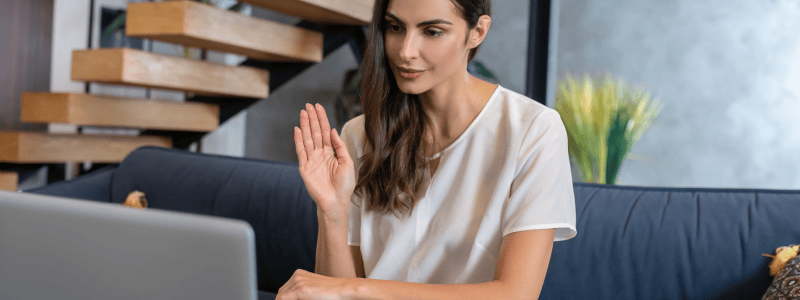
[23,166,117,202]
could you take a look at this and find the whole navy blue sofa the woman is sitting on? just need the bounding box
[26,147,800,299]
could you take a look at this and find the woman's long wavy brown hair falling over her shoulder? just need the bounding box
[355,0,492,214]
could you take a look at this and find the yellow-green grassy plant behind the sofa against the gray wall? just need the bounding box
[555,74,662,184]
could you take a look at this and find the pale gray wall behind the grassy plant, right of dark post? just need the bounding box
[555,0,800,189]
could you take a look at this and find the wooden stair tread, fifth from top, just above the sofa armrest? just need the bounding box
[0,131,172,163]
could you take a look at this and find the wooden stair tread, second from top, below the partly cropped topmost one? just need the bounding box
[125,1,323,62]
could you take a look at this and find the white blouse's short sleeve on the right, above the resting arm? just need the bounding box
[502,109,577,241]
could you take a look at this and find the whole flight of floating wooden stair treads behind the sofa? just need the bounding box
[0,0,373,185]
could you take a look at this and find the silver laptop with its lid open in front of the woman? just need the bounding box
[0,191,257,300]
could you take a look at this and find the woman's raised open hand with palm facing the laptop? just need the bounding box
[294,104,356,214]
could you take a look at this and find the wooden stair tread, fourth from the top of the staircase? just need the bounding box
[20,92,219,132]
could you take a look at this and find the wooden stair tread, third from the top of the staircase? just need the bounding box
[71,48,269,98]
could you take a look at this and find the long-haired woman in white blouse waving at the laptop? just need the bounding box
[277,0,576,299]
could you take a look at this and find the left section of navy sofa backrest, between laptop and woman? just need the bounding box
[110,147,318,292]
